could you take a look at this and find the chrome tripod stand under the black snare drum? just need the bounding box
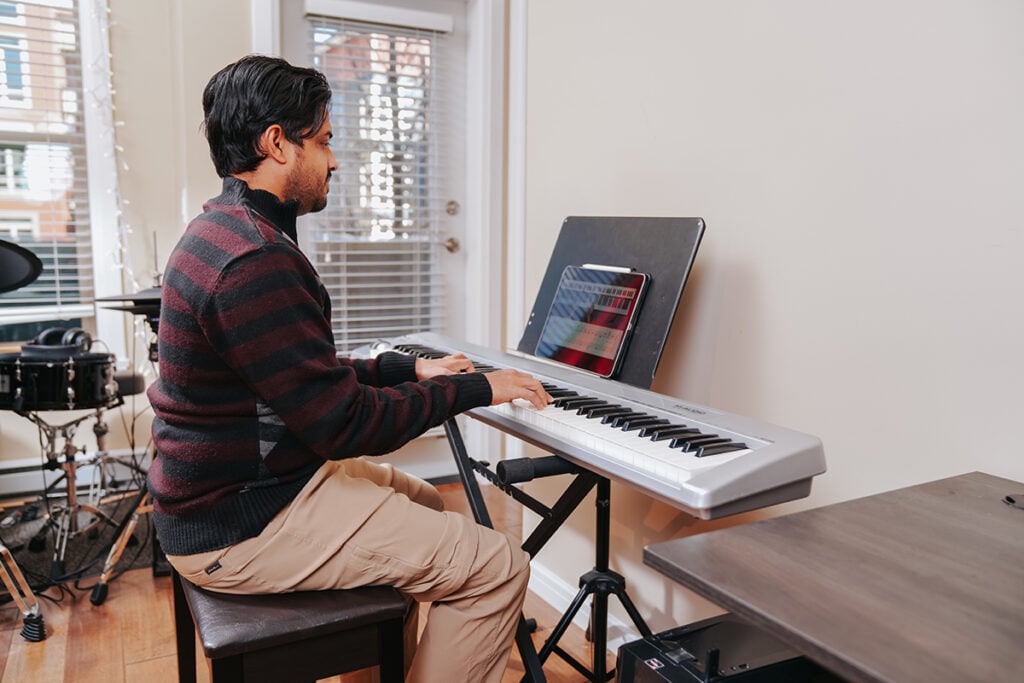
[22,409,117,581]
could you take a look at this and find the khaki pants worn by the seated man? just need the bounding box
[168,459,529,683]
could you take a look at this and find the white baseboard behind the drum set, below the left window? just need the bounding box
[0,449,148,499]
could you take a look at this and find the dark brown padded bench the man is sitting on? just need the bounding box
[172,571,408,683]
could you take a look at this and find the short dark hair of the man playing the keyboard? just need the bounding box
[203,54,331,178]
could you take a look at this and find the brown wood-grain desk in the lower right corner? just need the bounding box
[644,472,1024,683]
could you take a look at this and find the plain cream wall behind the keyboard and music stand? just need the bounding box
[524,0,1024,643]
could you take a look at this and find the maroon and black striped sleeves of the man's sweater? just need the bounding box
[202,245,492,460]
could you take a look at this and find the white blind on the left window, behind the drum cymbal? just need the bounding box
[0,0,94,327]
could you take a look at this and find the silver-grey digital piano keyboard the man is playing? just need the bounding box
[391,333,825,519]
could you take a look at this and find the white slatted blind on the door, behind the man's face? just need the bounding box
[303,15,449,352]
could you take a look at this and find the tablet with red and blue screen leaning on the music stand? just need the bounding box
[535,265,650,378]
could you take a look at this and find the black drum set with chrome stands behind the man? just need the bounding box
[0,240,159,641]
